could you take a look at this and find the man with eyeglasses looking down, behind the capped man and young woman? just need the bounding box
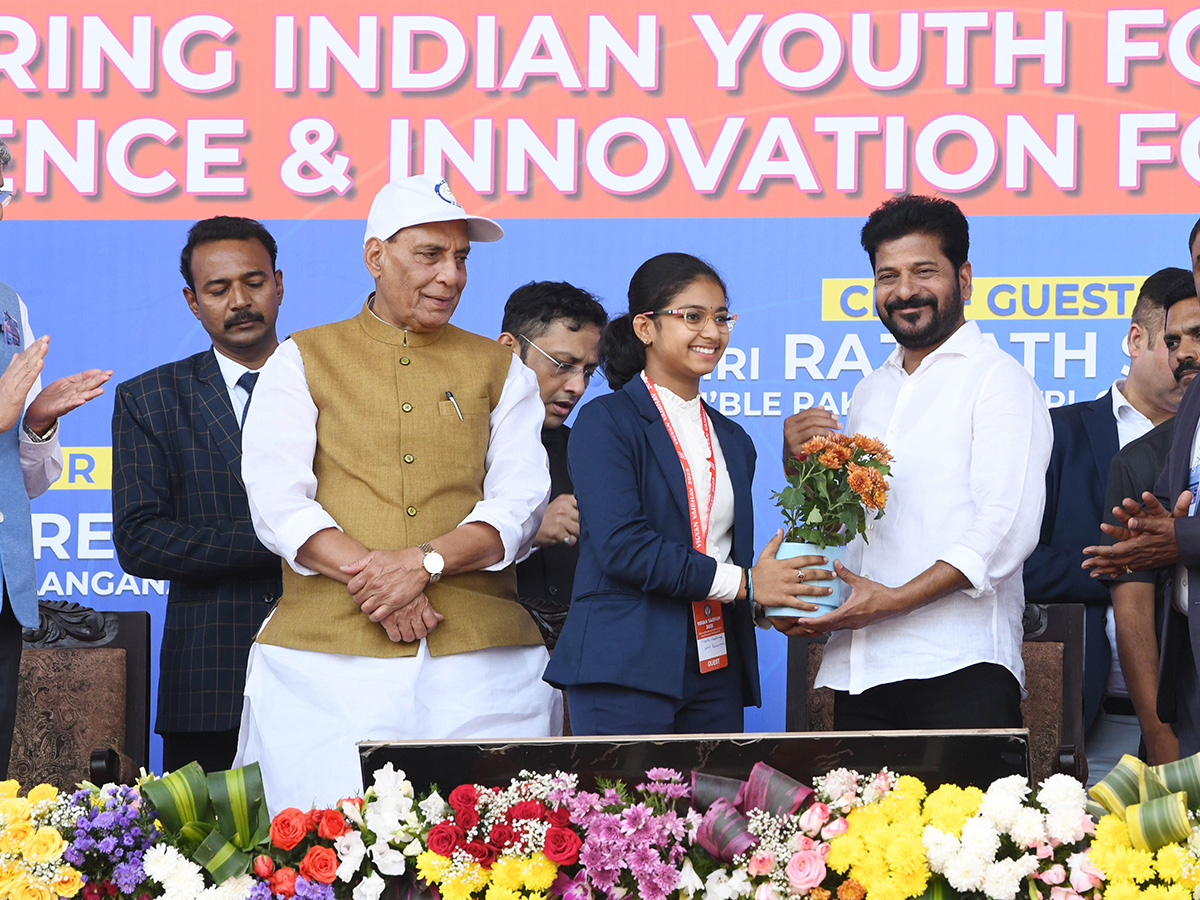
[496,281,608,649]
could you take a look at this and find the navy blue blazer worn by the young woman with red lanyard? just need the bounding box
[545,378,762,706]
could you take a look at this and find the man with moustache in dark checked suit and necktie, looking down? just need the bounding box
[113,216,283,772]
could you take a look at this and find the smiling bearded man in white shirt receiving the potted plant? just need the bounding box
[776,196,1050,730]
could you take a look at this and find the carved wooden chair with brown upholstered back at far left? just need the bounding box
[8,600,150,790]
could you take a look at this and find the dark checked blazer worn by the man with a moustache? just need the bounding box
[113,349,281,733]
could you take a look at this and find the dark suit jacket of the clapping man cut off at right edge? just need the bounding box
[1154,385,1200,757]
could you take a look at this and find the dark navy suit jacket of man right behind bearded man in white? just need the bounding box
[1024,391,1118,726]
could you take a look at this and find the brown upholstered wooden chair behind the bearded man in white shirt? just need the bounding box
[785,604,1085,784]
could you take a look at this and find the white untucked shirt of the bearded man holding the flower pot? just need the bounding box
[816,322,1051,694]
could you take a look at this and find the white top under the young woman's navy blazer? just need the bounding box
[654,376,742,602]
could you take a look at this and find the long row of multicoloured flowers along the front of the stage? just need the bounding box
[25,756,1200,900]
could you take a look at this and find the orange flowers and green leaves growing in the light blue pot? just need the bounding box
[772,432,892,548]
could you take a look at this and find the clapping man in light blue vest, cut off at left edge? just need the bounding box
[0,140,113,779]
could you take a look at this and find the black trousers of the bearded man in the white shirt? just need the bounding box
[833,662,1021,731]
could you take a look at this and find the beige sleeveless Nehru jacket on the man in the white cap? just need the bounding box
[258,306,541,656]
